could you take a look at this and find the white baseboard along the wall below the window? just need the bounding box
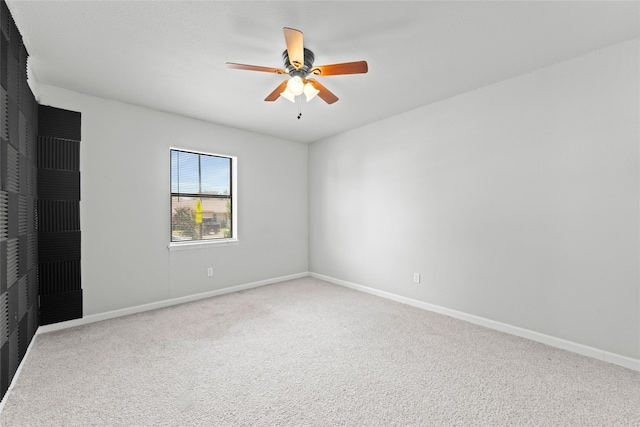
[36,272,309,335]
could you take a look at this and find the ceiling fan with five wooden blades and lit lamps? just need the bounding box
[227,27,369,104]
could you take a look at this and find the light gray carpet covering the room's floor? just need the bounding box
[0,278,640,427]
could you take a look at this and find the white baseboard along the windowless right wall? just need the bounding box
[309,273,640,371]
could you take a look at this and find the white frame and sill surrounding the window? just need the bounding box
[168,146,239,251]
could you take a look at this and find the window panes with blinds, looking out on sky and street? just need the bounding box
[171,149,236,242]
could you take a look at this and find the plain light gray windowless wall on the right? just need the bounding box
[309,40,640,359]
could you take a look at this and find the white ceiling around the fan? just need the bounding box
[7,0,640,142]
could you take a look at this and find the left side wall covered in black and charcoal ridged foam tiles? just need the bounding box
[0,0,40,398]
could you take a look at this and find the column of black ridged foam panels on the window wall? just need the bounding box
[37,105,82,325]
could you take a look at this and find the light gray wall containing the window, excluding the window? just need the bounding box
[38,86,308,316]
